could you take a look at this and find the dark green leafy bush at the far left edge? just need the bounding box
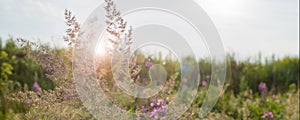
[1,38,54,89]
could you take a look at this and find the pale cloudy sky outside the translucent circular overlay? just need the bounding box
[0,0,299,57]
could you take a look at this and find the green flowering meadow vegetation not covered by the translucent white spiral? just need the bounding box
[0,39,299,120]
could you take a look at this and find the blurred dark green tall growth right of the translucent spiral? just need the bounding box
[227,55,300,94]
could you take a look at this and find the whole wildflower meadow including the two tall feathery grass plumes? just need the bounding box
[0,0,300,120]
